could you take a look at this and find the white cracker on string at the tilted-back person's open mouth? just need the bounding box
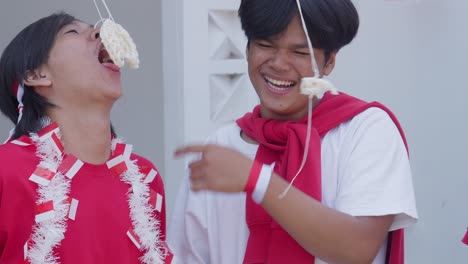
[93,0,140,69]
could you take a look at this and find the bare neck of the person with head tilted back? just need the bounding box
[49,109,111,164]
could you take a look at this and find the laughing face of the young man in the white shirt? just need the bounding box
[247,16,335,120]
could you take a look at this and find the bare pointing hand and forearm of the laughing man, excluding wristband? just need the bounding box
[176,145,394,264]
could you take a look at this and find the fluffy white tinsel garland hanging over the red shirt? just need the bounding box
[25,129,168,264]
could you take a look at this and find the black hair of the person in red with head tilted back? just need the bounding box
[0,12,76,139]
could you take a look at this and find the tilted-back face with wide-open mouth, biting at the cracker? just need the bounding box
[35,21,122,109]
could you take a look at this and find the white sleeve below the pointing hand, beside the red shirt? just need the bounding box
[168,172,210,264]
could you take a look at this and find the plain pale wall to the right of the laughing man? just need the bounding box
[333,0,468,264]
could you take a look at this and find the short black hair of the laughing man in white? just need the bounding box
[239,0,359,53]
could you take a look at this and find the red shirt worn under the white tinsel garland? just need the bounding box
[0,143,166,264]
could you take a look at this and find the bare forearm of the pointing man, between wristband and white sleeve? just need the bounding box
[262,174,394,264]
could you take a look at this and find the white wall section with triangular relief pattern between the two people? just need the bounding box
[162,0,258,219]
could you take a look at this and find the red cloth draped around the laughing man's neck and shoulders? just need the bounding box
[237,93,406,264]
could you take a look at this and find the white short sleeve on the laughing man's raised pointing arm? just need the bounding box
[335,108,418,231]
